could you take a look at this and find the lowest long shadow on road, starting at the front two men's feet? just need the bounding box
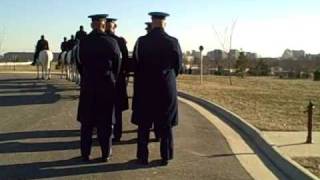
[0,158,160,179]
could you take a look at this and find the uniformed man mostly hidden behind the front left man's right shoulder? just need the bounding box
[106,18,129,142]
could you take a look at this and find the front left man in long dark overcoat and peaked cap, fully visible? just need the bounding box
[77,14,121,161]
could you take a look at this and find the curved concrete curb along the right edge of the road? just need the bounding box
[178,91,319,180]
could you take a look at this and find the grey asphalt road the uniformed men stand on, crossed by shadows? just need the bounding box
[0,74,252,180]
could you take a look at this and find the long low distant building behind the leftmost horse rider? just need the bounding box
[2,52,59,61]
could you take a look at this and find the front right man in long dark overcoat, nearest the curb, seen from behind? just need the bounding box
[132,12,182,165]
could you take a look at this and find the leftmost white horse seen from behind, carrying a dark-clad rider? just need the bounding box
[36,50,53,80]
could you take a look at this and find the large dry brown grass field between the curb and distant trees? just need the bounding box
[178,75,320,131]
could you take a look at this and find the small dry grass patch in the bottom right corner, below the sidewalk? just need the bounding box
[293,157,320,178]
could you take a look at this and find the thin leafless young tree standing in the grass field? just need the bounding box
[213,18,237,85]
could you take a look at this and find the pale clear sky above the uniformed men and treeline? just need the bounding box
[0,0,320,57]
